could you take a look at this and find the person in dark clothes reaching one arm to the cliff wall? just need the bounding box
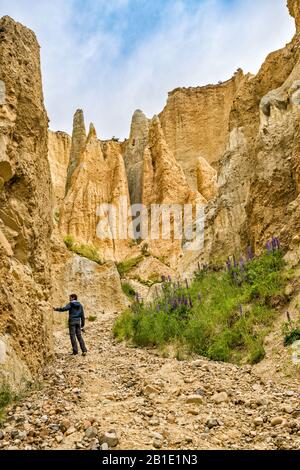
[54,294,87,356]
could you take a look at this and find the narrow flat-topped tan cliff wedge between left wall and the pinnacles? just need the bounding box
[48,131,72,210]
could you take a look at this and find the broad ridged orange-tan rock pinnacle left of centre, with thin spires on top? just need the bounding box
[60,112,130,260]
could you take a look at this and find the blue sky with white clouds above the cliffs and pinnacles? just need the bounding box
[0,0,295,139]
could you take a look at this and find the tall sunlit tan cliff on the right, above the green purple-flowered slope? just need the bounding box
[205,1,300,258]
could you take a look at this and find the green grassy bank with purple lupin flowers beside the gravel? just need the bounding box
[114,249,287,364]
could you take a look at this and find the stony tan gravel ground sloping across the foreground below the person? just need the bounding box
[0,314,300,450]
